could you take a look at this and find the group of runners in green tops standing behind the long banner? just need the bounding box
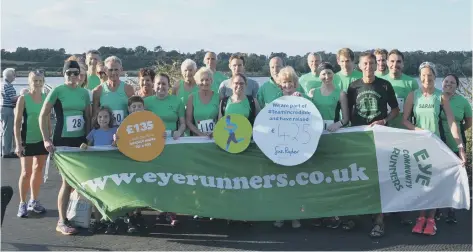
[2,48,472,237]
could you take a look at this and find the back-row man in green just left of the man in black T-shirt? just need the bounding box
[333,48,363,92]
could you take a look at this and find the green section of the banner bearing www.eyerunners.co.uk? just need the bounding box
[54,131,381,221]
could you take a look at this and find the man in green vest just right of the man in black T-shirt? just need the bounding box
[380,49,419,129]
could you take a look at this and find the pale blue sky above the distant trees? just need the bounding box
[1,0,472,55]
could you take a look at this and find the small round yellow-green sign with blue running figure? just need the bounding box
[213,114,253,154]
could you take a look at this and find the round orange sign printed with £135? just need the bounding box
[117,111,165,162]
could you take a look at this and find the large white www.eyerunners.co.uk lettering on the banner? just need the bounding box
[81,163,369,192]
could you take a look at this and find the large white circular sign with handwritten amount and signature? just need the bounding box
[253,96,324,166]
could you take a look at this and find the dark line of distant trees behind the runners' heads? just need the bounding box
[1,46,472,76]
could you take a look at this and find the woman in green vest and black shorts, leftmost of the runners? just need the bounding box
[14,71,48,218]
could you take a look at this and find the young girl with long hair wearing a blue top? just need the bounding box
[80,107,117,233]
